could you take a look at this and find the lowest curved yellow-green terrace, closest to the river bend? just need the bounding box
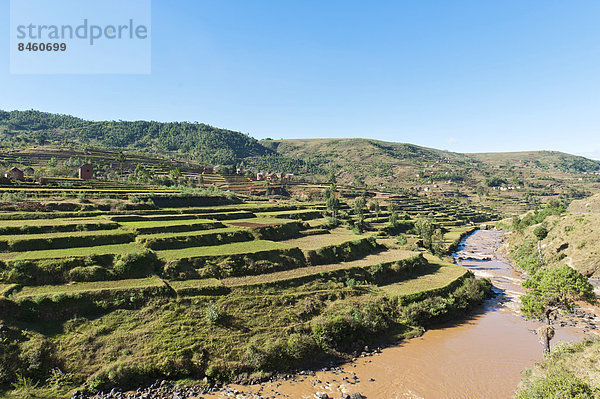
[381,256,468,297]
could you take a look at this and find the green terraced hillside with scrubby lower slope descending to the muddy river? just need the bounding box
[0,194,496,398]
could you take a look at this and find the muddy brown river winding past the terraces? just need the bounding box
[208,230,595,399]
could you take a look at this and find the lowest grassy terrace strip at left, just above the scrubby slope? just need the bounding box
[14,277,164,299]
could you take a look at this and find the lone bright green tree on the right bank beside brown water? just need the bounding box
[521,265,594,353]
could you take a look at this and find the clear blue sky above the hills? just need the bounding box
[0,0,600,158]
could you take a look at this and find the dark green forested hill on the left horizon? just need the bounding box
[0,110,318,172]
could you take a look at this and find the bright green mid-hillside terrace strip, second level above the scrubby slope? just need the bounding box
[156,240,292,260]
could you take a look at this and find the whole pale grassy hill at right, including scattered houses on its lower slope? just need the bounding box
[261,139,600,210]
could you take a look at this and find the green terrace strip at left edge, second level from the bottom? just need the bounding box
[10,243,143,260]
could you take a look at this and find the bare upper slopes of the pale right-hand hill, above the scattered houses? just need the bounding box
[261,139,600,193]
